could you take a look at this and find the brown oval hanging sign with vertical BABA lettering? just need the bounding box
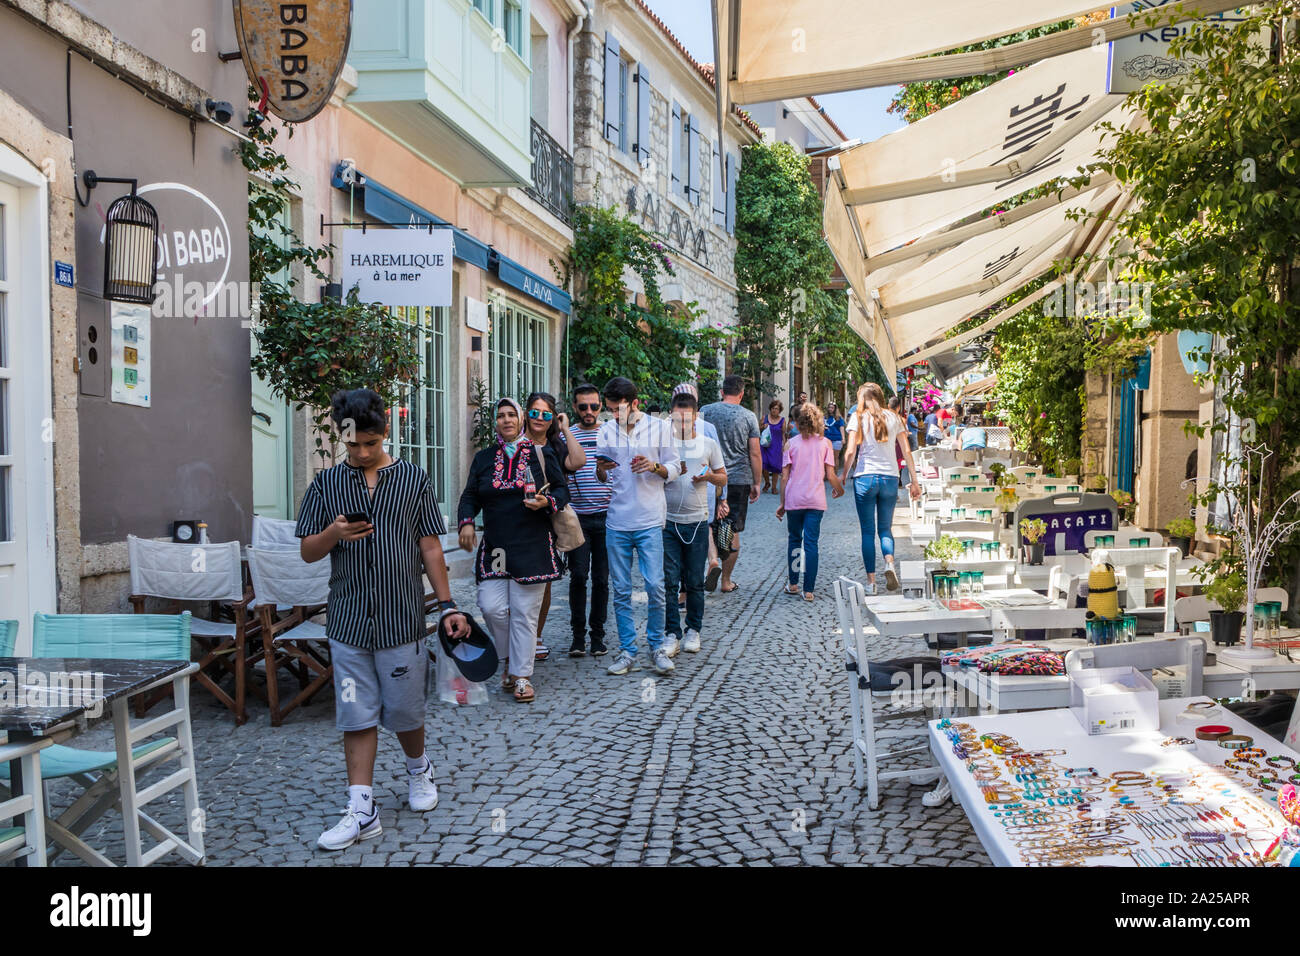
[234,0,352,122]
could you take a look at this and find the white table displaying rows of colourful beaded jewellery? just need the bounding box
[930,697,1300,866]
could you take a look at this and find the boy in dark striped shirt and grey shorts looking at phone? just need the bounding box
[296,389,469,849]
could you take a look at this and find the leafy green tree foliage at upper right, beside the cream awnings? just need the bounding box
[1089,0,1300,582]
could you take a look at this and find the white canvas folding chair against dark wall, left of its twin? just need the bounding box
[126,535,257,724]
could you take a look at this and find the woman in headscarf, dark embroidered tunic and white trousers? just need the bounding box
[458,398,569,704]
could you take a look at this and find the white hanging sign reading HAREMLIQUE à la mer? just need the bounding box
[343,229,451,306]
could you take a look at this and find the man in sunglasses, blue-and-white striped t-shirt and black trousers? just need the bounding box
[566,382,612,657]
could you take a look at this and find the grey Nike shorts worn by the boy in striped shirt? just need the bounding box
[329,640,429,734]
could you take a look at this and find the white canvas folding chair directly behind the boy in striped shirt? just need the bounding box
[248,548,334,727]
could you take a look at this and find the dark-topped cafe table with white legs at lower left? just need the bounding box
[0,657,202,866]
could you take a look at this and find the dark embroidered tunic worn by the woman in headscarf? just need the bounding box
[456,437,569,584]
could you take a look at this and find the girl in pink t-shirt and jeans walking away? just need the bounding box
[776,402,844,601]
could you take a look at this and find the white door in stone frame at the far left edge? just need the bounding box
[0,175,57,653]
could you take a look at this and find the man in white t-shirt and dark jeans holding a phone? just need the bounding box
[663,392,727,654]
